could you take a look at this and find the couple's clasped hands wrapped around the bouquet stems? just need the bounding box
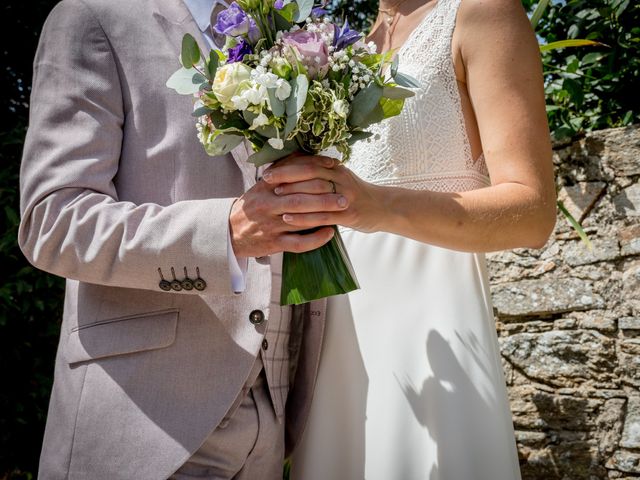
[229,154,384,257]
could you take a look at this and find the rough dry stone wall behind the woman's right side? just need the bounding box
[488,126,640,480]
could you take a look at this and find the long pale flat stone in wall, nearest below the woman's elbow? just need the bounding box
[492,277,604,317]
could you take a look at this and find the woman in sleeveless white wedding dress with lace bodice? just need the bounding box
[264,0,555,480]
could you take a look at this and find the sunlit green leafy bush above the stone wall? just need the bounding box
[537,0,640,138]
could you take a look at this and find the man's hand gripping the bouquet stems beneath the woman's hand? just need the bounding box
[229,155,348,257]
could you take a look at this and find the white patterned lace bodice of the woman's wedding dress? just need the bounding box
[347,0,490,192]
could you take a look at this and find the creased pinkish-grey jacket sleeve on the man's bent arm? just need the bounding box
[18,0,234,295]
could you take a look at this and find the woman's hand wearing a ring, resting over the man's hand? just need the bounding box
[263,155,388,232]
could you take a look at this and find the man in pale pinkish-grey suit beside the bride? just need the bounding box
[19,0,342,480]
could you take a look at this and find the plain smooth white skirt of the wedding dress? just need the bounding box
[292,229,520,480]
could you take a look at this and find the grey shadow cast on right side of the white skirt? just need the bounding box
[399,330,514,480]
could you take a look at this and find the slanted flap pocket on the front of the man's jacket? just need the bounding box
[64,309,178,364]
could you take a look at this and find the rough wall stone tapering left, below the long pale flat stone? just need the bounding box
[499,330,616,388]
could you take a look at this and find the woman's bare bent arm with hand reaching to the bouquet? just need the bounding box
[268,0,556,255]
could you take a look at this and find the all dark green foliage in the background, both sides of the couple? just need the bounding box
[0,0,640,479]
